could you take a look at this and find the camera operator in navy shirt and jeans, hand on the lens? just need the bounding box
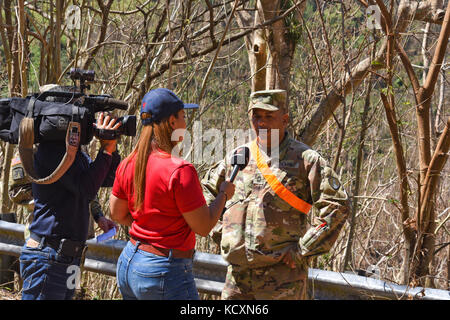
[20,107,120,300]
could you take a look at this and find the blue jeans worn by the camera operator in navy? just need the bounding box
[20,242,81,300]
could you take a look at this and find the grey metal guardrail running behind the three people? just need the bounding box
[0,220,450,300]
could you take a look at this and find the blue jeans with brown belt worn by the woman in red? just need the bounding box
[117,241,199,300]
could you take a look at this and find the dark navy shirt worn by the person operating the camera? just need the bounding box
[29,142,120,241]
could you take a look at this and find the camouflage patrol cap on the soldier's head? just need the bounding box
[248,89,287,112]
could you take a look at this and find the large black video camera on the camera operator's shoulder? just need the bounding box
[0,68,136,144]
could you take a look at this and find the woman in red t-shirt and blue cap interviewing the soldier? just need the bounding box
[110,88,234,300]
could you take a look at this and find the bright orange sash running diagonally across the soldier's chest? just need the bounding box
[250,140,311,214]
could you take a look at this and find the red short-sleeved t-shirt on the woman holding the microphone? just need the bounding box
[112,151,206,250]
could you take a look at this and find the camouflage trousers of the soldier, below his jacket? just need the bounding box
[221,263,308,300]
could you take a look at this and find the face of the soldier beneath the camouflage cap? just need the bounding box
[250,109,289,147]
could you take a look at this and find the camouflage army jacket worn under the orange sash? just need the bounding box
[202,135,350,268]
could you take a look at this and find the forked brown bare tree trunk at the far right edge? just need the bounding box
[361,0,450,285]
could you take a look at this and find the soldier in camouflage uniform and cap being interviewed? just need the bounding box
[202,90,350,300]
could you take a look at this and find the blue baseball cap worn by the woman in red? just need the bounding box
[141,88,198,126]
